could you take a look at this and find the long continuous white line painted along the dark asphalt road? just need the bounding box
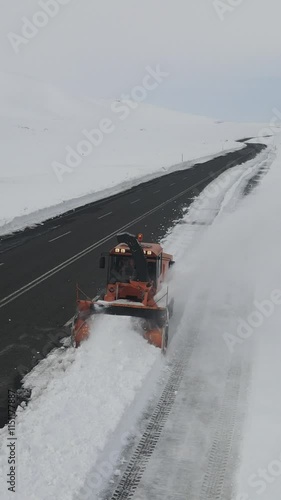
[0,179,212,309]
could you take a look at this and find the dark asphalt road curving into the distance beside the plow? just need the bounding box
[0,139,264,426]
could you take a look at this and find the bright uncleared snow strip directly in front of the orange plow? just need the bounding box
[0,317,160,500]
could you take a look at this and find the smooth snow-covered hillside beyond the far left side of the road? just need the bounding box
[0,73,262,234]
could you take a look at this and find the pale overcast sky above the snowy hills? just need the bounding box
[0,0,281,121]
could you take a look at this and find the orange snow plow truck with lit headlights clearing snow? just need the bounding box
[72,233,174,352]
